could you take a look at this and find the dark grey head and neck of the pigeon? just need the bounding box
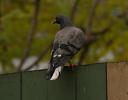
[54,15,72,29]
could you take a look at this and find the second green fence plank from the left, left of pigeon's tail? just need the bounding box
[22,71,47,100]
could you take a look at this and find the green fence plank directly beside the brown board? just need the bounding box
[77,64,106,100]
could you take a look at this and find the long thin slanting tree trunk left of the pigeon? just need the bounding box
[18,0,40,71]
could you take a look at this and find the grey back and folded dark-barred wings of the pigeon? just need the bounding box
[51,27,85,67]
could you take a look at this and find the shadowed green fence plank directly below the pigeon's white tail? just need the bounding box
[48,70,75,100]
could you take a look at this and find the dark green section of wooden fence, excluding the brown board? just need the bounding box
[0,64,107,100]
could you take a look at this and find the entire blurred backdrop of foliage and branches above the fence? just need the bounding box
[0,0,128,74]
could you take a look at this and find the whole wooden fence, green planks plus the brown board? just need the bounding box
[0,62,128,100]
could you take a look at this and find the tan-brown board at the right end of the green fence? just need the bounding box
[107,62,128,100]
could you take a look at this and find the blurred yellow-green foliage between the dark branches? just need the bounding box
[0,0,128,71]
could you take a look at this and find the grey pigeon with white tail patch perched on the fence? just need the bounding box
[46,15,86,80]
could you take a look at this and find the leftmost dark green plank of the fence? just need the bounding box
[0,73,20,100]
